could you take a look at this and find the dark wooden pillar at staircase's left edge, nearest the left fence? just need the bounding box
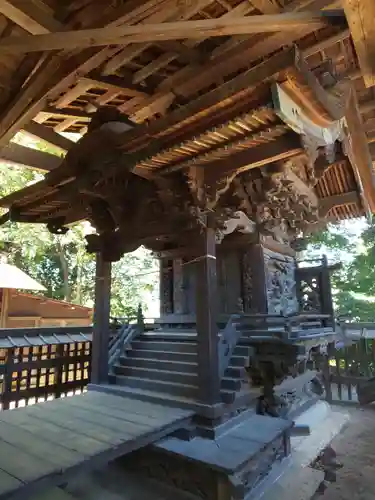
[91,253,111,384]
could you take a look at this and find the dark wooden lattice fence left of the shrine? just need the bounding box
[0,327,92,409]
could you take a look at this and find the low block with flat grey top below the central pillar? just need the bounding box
[123,412,293,500]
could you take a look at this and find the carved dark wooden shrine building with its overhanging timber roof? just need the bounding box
[0,0,375,500]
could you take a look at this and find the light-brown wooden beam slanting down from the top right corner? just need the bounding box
[342,0,375,87]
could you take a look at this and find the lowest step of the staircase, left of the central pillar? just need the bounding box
[116,375,198,398]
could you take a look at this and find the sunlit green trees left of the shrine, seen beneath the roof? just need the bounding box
[0,136,158,317]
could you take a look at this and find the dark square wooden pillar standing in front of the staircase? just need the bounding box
[195,227,220,405]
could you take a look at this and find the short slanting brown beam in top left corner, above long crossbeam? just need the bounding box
[0,0,64,35]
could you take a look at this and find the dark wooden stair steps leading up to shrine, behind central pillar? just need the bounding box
[111,329,251,404]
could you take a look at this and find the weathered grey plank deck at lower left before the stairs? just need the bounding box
[0,391,192,500]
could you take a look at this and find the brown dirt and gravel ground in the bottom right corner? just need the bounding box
[322,407,375,500]
